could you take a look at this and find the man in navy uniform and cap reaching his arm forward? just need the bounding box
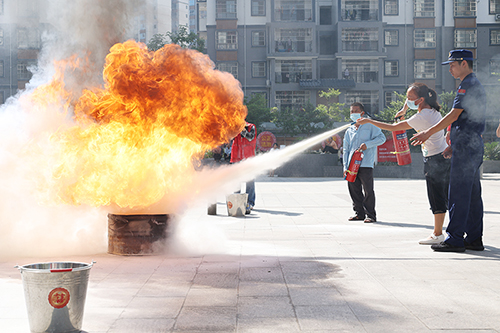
[411,50,486,252]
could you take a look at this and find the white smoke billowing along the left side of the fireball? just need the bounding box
[0,0,135,259]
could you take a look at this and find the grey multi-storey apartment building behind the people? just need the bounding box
[202,0,500,113]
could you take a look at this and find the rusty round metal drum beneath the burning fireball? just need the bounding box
[108,214,169,255]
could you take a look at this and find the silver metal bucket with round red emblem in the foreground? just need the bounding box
[16,261,95,333]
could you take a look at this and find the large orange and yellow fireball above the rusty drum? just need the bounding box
[33,41,247,209]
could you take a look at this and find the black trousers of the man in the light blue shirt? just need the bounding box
[347,168,377,220]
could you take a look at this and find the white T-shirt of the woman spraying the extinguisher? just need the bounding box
[407,109,448,157]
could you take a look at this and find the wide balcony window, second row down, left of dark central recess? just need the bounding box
[274,28,313,52]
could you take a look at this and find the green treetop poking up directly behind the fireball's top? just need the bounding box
[147,24,205,53]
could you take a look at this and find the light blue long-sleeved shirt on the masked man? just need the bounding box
[343,124,385,171]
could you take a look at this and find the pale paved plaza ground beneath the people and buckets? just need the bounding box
[0,174,500,333]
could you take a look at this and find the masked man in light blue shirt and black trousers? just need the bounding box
[343,102,385,223]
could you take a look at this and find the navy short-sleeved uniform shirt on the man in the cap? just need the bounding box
[450,73,486,146]
